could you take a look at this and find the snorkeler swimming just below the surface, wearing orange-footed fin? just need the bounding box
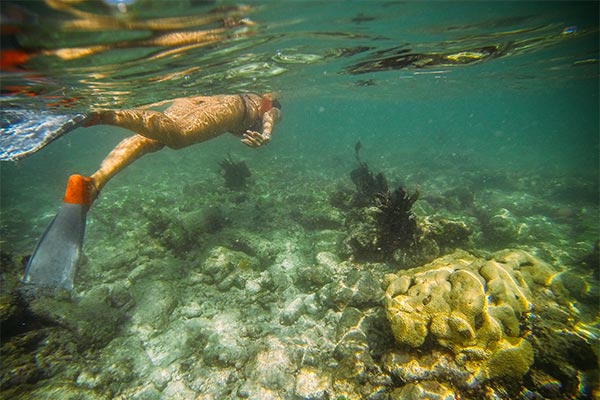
[12,94,281,290]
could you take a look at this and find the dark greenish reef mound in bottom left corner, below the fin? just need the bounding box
[0,250,134,399]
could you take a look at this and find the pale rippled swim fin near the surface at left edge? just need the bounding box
[0,109,86,161]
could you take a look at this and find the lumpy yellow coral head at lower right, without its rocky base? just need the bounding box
[385,251,554,379]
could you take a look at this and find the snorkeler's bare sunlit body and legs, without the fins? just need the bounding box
[86,94,281,198]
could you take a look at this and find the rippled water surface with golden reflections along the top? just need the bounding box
[2,1,598,110]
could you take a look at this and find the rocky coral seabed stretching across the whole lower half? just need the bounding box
[0,152,600,400]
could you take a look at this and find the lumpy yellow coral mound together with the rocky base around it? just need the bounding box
[383,251,598,398]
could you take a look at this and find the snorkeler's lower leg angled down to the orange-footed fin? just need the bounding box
[91,135,164,200]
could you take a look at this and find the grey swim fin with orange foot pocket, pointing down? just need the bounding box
[23,175,92,290]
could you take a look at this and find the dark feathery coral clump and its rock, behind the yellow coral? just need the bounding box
[338,142,473,268]
